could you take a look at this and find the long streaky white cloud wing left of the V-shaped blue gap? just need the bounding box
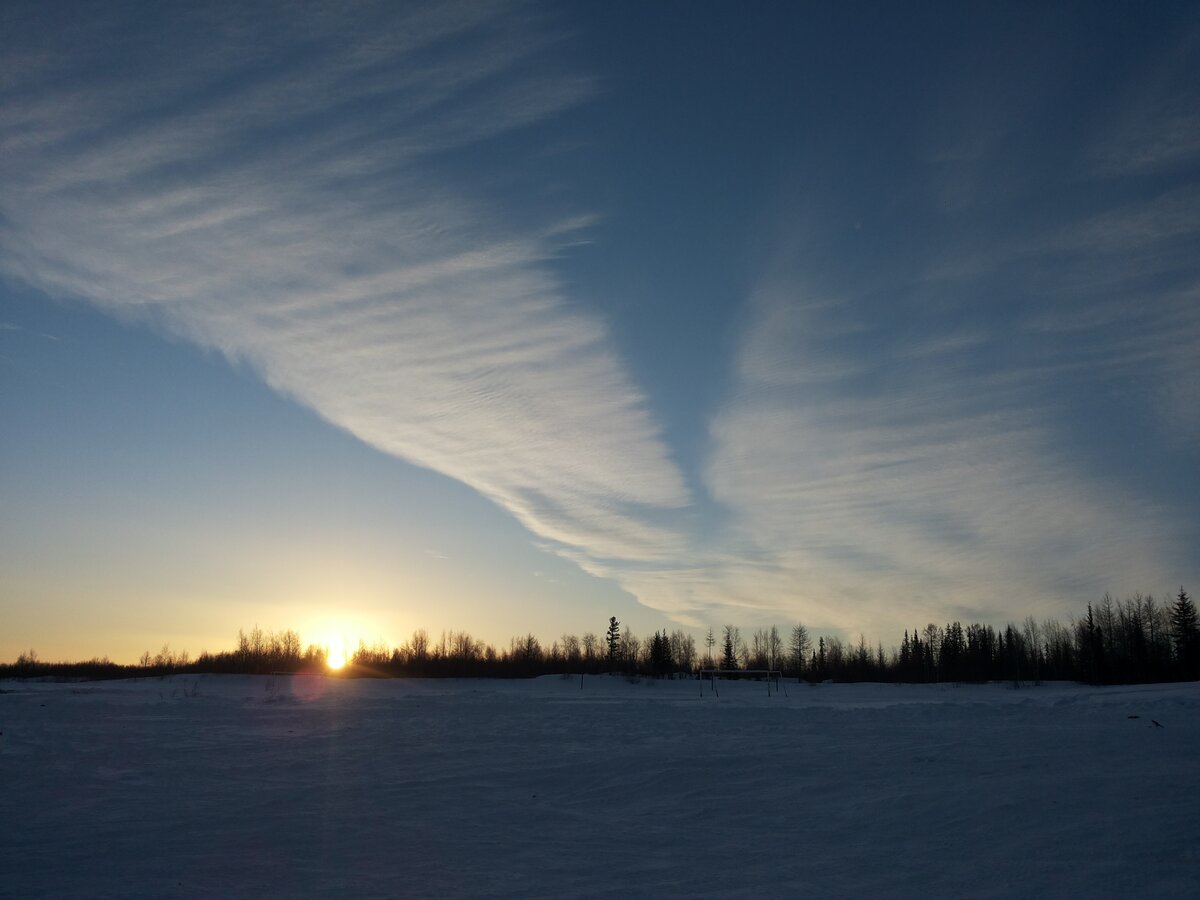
[0,2,688,571]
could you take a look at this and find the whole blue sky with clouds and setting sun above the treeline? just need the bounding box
[0,0,1200,661]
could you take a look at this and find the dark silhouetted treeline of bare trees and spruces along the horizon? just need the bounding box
[0,588,1200,684]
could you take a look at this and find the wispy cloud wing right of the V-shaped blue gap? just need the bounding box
[676,65,1200,635]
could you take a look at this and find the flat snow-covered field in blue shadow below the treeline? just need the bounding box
[0,676,1200,899]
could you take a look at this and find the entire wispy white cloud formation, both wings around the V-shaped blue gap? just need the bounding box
[0,2,1200,638]
